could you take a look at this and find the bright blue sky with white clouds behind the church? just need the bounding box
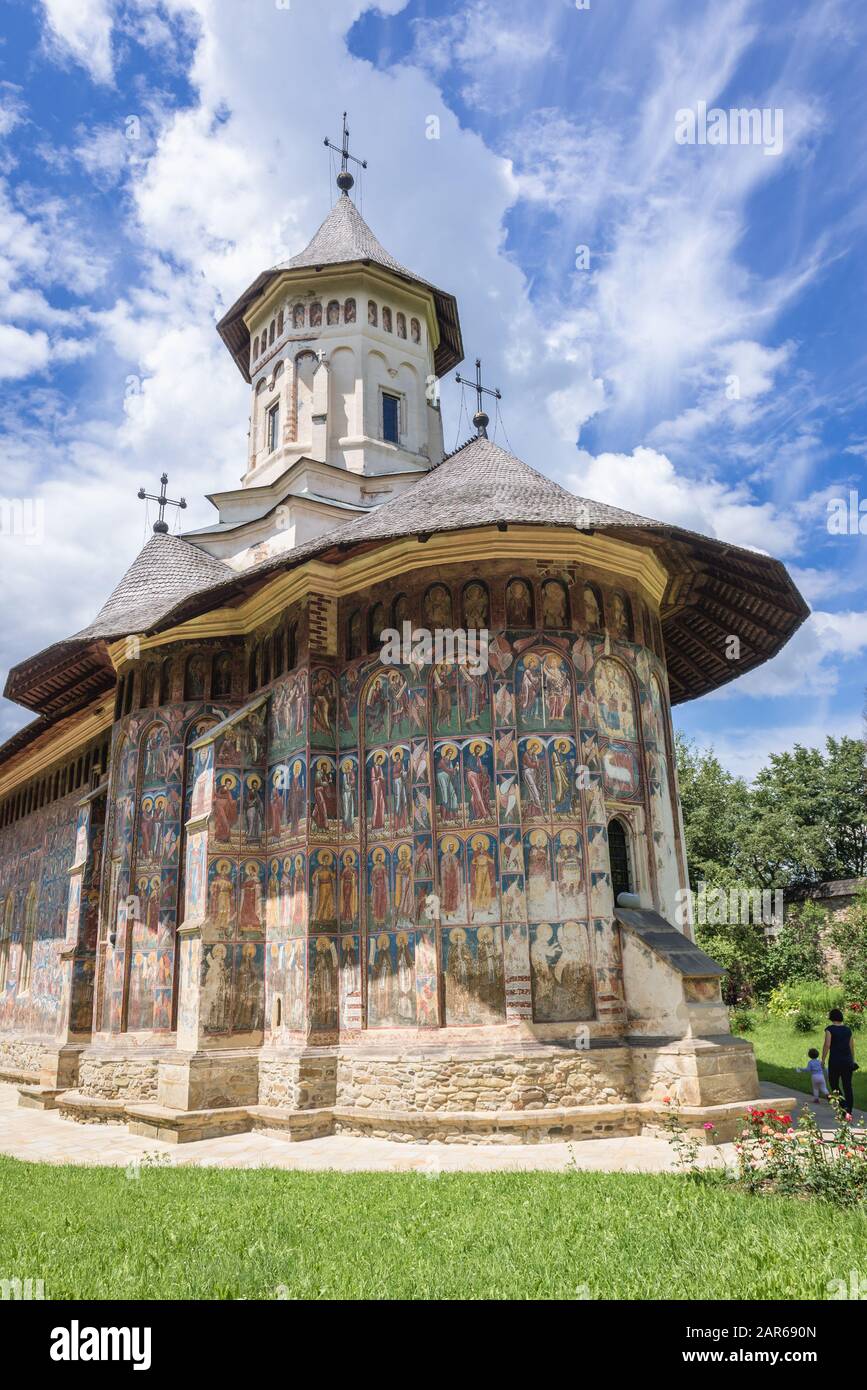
[0,0,867,776]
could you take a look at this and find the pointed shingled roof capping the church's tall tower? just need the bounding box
[217,193,464,381]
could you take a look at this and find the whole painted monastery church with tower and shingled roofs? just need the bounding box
[0,161,807,1141]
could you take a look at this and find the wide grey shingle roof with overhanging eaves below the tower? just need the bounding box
[0,438,810,762]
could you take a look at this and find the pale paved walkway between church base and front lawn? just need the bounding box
[0,1081,834,1173]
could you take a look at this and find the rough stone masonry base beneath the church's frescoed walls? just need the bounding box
[21,1036,793,1144]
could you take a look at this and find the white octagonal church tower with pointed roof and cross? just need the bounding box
[188,115,463,570]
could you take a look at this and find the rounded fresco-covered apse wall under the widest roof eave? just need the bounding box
[319,564,681,1031]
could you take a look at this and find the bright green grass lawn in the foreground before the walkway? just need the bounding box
[0,1158,867,1300]
